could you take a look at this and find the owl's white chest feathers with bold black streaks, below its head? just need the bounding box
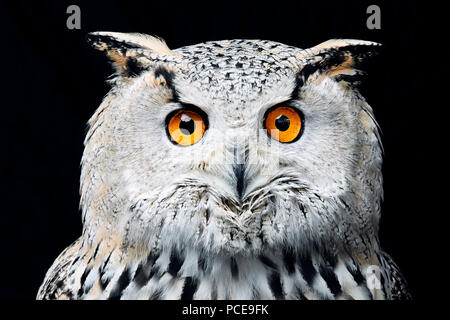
[74,246,383,300]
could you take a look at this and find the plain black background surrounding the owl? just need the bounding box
[0,0,442,299]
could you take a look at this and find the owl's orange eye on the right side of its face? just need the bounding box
[264,106,303,143]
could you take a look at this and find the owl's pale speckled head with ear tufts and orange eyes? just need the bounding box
[81,32,382,255]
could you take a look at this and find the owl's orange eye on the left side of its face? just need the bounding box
[167,109,206,146]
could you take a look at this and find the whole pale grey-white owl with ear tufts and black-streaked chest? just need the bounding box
[37,32,410,300]
